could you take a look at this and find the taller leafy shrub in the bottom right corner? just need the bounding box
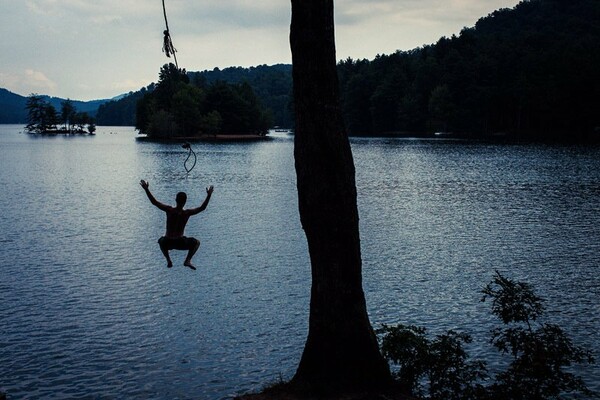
[482,271,594,400]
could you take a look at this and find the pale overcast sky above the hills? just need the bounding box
[0,0,519,100]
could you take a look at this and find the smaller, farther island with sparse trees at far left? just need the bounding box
[25,94,96,135]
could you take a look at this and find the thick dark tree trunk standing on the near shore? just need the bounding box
[290,0,391,392]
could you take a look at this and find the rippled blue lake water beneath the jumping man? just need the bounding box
[0,126,600,399]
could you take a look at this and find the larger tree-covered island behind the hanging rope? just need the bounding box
[135,64,272,141]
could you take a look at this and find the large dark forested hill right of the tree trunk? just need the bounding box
[339,0,600,140]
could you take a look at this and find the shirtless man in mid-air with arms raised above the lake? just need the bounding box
[140,179,214,270]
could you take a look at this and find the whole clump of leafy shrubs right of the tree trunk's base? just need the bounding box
[378,272,596,400]
